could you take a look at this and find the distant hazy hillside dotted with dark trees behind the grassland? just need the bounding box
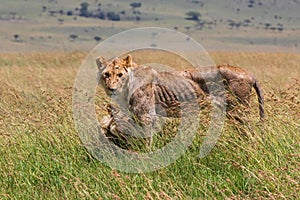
[0,0,300,52]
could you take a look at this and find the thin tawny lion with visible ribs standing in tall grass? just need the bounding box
[96,55,264,146]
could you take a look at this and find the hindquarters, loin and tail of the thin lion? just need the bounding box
[179,65,265,121]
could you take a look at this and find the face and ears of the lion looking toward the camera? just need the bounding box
[96,55,132,95]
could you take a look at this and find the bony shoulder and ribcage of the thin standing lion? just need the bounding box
[128,67,202,117]
